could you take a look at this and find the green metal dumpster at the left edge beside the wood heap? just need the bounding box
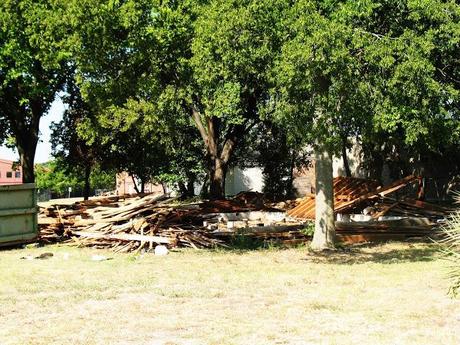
[0,183,38,246]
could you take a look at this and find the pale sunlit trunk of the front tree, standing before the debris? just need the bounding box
[311,148,335,251]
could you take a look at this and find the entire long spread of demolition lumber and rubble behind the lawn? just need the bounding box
[38,176,451,252]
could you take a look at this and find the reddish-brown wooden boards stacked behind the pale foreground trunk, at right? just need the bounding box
[288,175,453,242]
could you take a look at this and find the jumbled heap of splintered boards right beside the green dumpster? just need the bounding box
[38,196,225,252]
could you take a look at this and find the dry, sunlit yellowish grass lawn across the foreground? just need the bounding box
[0,243,460,345]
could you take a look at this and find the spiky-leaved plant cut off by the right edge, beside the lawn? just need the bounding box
[442,211,460,296]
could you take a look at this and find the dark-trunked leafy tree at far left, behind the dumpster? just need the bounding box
[0,0,67,182]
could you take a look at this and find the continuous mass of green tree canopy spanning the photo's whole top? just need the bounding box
[0,0,460,247]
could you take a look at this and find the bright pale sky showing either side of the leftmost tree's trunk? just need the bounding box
[0,97,64,163]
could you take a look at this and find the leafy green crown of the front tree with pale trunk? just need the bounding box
[271,0,460,156]
